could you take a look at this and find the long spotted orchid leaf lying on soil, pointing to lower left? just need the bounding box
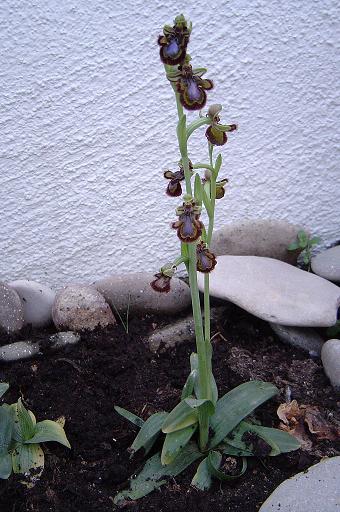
[113,443,202,505]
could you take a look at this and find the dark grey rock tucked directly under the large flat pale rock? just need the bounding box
[270,322,324,357]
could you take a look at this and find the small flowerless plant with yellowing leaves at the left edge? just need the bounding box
[0,383,71,485]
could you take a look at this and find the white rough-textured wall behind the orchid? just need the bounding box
[0,0,340,285]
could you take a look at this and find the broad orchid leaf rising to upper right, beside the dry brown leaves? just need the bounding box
[209,380,278,448]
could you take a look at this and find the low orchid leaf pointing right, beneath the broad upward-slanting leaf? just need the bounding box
[223,421,300,457]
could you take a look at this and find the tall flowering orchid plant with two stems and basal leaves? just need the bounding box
[114,15,299,505]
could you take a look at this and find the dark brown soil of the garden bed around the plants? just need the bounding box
[0,307,340,512]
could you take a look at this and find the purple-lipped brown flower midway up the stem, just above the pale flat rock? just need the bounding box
[171,199,203,243]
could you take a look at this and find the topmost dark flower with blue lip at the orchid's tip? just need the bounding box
[158,14,191,66]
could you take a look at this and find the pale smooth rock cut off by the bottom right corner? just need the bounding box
[259,457,340,512]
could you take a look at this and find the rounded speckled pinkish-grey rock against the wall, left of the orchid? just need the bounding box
[52,284,116,331]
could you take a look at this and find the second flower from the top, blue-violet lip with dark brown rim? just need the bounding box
[176,63,214,110]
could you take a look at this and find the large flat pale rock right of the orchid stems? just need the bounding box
[198,256,340,327]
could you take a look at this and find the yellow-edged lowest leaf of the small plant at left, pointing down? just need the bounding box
[12,443,44,478]
